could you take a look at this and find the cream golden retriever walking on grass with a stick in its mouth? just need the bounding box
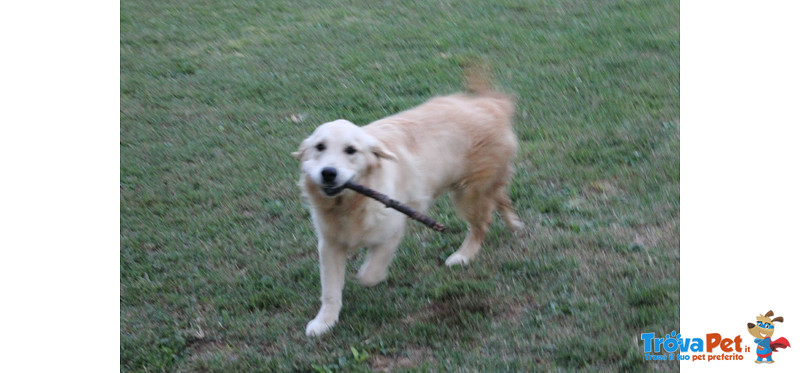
[292,77,523,336]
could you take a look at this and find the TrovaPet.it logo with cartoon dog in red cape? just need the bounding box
[640,311,791,364]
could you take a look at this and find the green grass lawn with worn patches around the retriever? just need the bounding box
[120,0,680,372]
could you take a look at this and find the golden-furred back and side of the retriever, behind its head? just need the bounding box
[364,86,517,208]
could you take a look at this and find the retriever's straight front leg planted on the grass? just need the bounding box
[306,242,347,337]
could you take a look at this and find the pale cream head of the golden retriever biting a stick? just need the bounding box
[292,119,397,197]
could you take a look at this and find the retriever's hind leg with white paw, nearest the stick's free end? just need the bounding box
[444,187,495,267]
